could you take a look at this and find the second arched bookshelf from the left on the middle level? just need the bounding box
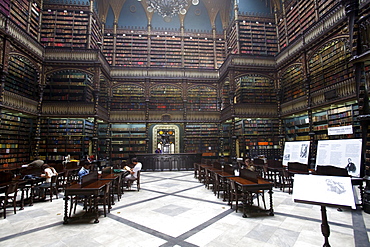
[44,70,93,102]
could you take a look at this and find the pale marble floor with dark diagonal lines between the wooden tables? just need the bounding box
[0,171,370,247]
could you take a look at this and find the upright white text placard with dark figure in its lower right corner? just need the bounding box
[316,139,362,177]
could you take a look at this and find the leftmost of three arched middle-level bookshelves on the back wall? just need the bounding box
[111,84,146,111]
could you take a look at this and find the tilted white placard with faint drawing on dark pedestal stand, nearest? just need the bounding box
[293,174,356,209]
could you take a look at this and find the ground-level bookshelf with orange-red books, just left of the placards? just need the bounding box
[235,118,281,159]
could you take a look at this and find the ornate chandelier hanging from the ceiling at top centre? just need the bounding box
[142,0,199,22]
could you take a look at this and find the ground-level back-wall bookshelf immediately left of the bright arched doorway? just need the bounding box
[110,123,147,161]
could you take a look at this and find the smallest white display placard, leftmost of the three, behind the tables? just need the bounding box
[283,141,310,166]
